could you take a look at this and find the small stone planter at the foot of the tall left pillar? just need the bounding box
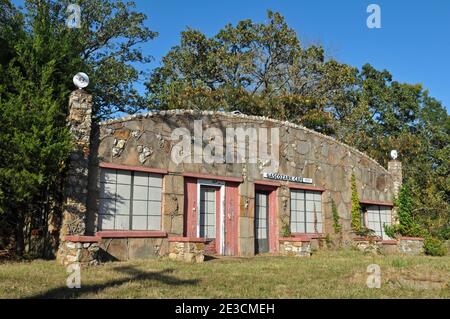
[57,236,100,266]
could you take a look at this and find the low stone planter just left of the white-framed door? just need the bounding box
[169,237,206,263]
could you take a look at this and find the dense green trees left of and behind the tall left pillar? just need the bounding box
[0,0,156,254]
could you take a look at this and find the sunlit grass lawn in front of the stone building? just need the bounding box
[0,250,450,298]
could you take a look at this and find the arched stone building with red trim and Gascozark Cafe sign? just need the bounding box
[59,90,401,260]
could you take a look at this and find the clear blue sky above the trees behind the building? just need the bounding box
[137,0,450,110]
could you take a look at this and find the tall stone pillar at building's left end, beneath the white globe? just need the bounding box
[60,89,92,250]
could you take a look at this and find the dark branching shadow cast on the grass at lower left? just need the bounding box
[27,266,199,299]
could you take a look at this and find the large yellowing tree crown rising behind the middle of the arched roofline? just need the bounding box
[147,11,356,133]
